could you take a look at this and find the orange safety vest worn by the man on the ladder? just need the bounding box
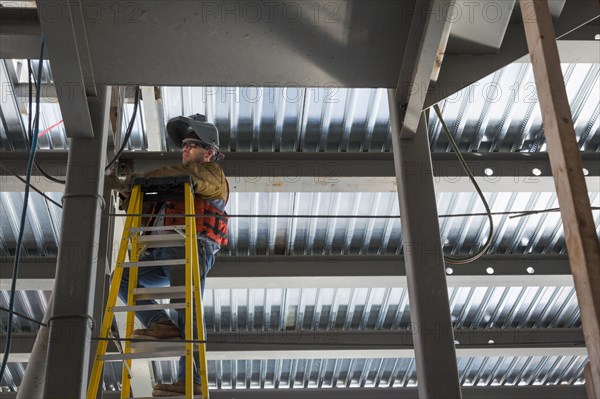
[165,195,229,245]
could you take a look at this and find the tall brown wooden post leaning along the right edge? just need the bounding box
[520,0,600,393]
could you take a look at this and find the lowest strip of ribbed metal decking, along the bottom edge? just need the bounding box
[139,356,587,395]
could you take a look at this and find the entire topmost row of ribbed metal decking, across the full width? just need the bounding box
[16,63,600,152]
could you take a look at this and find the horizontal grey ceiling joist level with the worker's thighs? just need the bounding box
[0,255,573,290]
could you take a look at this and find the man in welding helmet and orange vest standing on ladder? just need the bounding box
[109,114,229,396]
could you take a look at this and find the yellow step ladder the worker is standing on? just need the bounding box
[87,176,209,399]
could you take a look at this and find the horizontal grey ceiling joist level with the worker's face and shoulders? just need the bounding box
[0,151,600,192]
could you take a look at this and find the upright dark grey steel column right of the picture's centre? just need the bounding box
[388,97,461,399]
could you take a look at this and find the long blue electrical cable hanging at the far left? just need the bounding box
[0,33,45,381]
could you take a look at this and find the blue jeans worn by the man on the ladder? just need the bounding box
[119,237,220,384]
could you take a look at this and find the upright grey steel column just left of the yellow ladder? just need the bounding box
[44,88,110,398]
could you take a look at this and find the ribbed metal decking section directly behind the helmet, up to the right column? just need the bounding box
[162,86,391,152]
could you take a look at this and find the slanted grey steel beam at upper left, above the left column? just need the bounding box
[36,0,97,138]
